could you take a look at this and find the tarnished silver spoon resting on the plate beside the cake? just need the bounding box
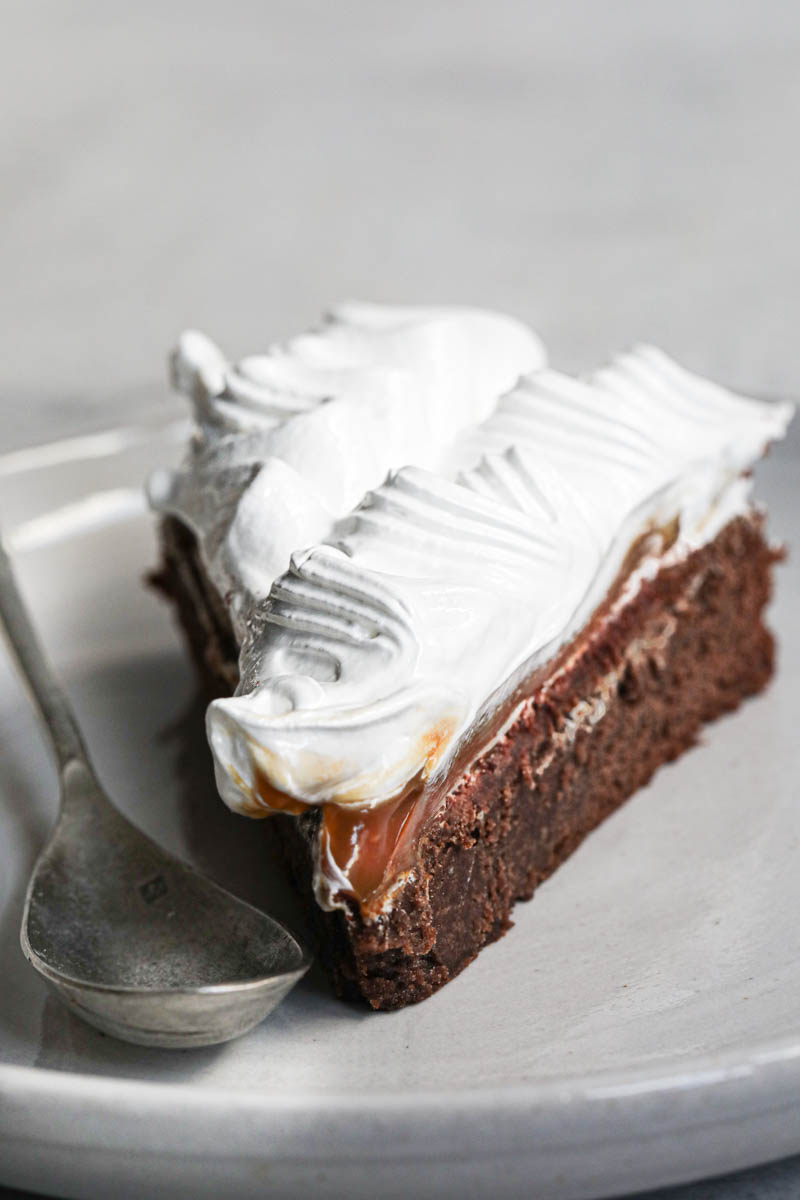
[0,538,309,1048]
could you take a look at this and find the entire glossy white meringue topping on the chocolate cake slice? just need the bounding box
[145,305,793,844]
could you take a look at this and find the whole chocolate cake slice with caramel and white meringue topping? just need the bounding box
[150,305,792,1008]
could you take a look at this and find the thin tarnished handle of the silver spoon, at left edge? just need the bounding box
[0,533,86,770]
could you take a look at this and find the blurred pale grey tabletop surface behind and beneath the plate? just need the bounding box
[0,0,800,1200]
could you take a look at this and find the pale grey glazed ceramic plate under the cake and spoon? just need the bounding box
[0,415,800,1198]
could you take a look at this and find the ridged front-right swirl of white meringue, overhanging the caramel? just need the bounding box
[207,335,793,815]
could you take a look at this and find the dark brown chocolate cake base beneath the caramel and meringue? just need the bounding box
[154,515,780,1009]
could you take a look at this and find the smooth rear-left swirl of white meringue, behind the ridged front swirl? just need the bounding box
[149,304,545,641]
